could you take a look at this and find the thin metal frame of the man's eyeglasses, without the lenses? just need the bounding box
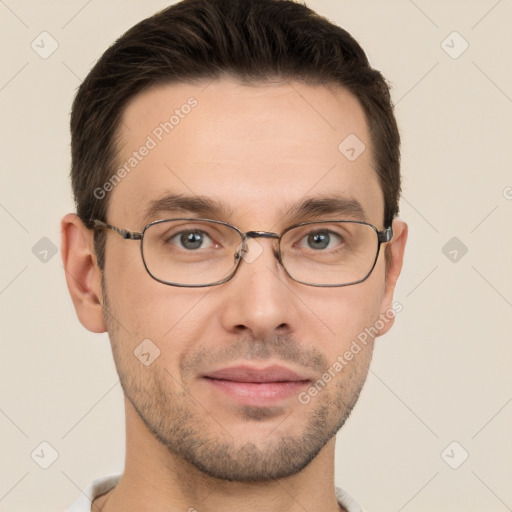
[91,217,393,288]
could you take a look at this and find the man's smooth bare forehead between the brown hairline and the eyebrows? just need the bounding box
[108,79,384,229]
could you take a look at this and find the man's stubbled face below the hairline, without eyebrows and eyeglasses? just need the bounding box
[103,80,396,480]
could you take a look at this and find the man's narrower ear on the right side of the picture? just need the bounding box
[377,219,408,336]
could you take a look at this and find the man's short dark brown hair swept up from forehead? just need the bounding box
[71,0,400,268]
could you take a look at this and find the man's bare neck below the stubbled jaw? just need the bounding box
[92,400,346,512]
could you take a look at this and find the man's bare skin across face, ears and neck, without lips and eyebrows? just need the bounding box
[62,78,407,512]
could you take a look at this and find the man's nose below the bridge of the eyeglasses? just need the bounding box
[222,238,301,339]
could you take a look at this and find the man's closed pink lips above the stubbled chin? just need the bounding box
[203,365,311,407]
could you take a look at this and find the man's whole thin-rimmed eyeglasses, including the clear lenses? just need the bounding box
[93,218,393,288]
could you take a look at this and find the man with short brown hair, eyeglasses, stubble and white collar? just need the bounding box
[62,0,407,512]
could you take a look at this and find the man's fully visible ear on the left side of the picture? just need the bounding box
[61,213,106,332]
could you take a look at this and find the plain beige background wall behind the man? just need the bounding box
[0,0,512,512]
